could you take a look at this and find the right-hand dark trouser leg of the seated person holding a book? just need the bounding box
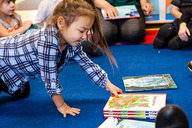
[119,9,146,43]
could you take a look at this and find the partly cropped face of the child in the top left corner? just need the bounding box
[0,0,15,15]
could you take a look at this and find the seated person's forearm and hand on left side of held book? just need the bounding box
[94,0,118,19]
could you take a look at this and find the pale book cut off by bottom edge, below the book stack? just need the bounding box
[98,117,155,128]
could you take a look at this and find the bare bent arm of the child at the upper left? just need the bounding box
[0,20,32,37]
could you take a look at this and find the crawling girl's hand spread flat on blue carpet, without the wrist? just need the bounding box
[57,102,81,117]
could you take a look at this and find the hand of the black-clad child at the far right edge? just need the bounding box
[178,22,191,41]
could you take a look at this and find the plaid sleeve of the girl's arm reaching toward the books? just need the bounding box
[73,46,108,88]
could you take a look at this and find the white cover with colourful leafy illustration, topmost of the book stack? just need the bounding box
[103,93,167,112]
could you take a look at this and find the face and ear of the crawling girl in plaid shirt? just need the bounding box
[57,16,94,46]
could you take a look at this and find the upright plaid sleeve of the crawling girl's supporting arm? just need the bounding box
[38,36,63,96]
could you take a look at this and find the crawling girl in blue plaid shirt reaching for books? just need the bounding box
[0,0,122,117]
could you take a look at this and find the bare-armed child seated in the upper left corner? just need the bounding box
[0,0,32,37]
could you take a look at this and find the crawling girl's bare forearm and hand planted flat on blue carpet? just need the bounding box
[51,95,81,117]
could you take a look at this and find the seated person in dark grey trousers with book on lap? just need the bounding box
[94,0,153,45]
